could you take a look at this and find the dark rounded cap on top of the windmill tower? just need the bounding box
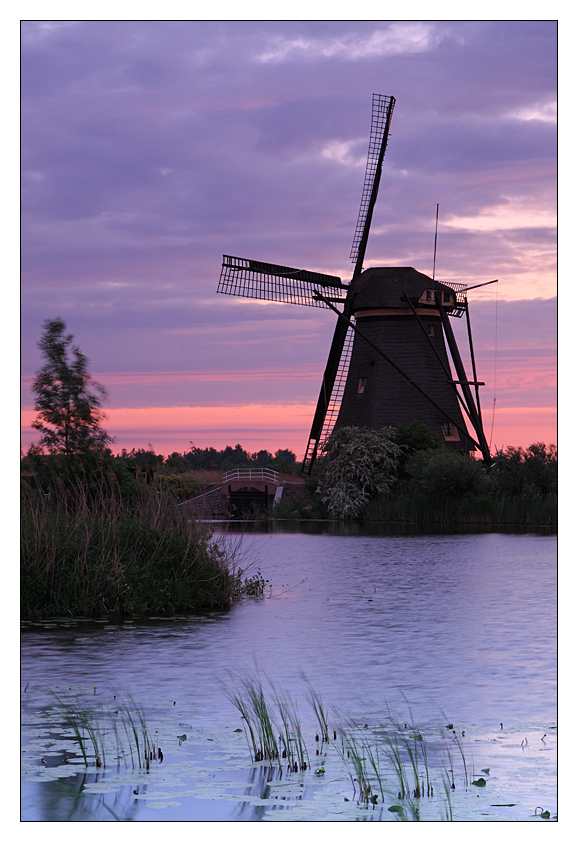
[352,266,455,312]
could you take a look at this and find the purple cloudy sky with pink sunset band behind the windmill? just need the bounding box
[21,20,557,457]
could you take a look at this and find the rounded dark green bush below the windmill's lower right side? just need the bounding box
[405,447,485,497]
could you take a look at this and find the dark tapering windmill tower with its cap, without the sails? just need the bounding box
[335,267,474,451]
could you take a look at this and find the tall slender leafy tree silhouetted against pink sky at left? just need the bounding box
[32,319,113,456]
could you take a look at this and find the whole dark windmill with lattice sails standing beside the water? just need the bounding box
[217,94,495,473]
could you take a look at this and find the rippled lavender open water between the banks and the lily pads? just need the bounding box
[22,527,556,821]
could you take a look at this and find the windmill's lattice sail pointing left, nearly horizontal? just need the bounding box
[217,254,347,307]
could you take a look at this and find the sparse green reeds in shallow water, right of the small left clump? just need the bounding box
[225,676,484,821]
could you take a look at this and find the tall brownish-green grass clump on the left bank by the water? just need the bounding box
[21,480,239,618]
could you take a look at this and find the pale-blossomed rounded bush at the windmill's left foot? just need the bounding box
[317,427,401,519]
